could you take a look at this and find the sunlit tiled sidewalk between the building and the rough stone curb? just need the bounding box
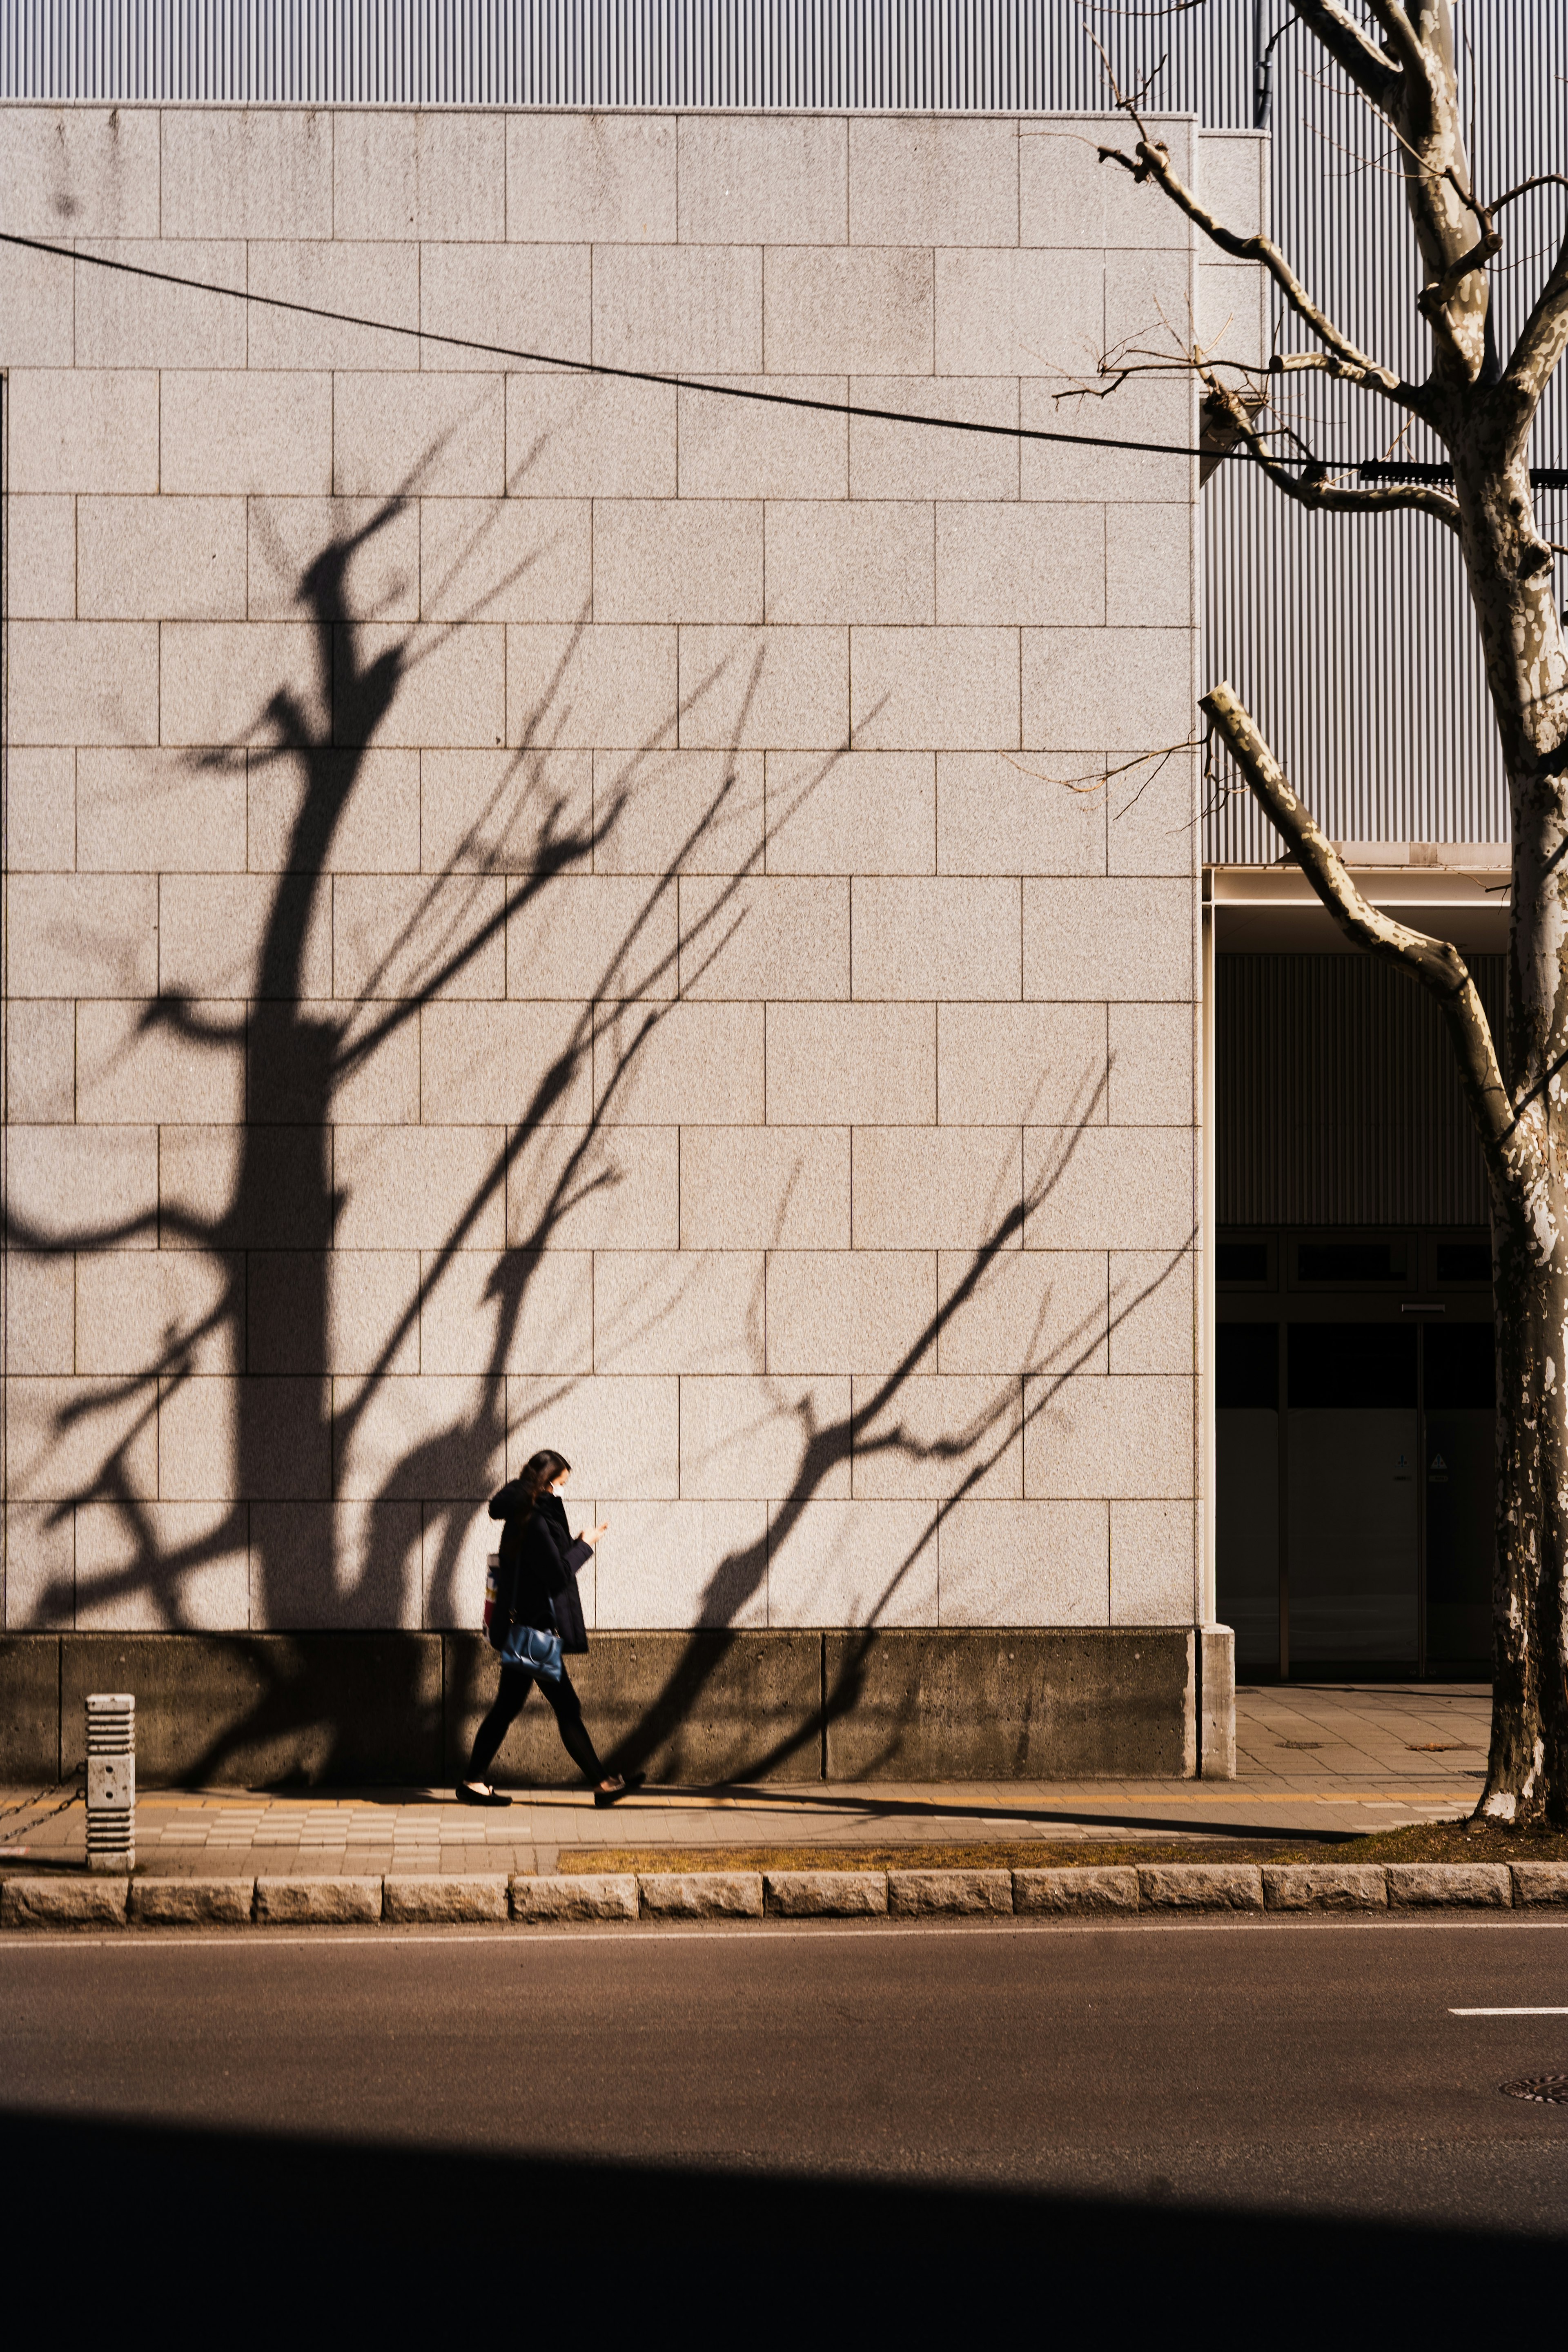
[0,1684,1490,1877]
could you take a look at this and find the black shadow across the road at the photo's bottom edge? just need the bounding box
[0,2107,1561,2305]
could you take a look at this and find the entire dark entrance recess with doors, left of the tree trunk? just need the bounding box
[1213,955,1505,1679]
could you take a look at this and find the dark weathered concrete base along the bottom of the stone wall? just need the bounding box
[0,1625,1234,1788]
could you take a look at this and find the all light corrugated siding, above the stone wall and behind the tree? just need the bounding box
[0,0,1568,863]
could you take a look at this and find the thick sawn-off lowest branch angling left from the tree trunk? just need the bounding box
[1199,684,1523,1190]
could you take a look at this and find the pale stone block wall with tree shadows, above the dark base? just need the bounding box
[0,108,1213,1630]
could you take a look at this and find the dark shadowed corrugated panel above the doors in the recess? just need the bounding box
[1215,955,1505,1225]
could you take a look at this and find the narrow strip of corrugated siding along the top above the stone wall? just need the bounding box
[0,0,1253,110]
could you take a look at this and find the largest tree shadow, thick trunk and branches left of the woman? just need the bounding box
[5,461,757,1778]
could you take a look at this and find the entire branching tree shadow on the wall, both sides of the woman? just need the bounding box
[7,461,1185,1780]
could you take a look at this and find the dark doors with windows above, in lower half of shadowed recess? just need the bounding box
[1215,1228,1495,1679]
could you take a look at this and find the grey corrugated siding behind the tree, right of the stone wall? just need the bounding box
[1204,0,1568,863]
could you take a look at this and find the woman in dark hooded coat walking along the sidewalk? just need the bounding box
[459,1449,642,1804]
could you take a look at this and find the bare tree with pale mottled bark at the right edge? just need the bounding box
[1100,0,1568,1823]
